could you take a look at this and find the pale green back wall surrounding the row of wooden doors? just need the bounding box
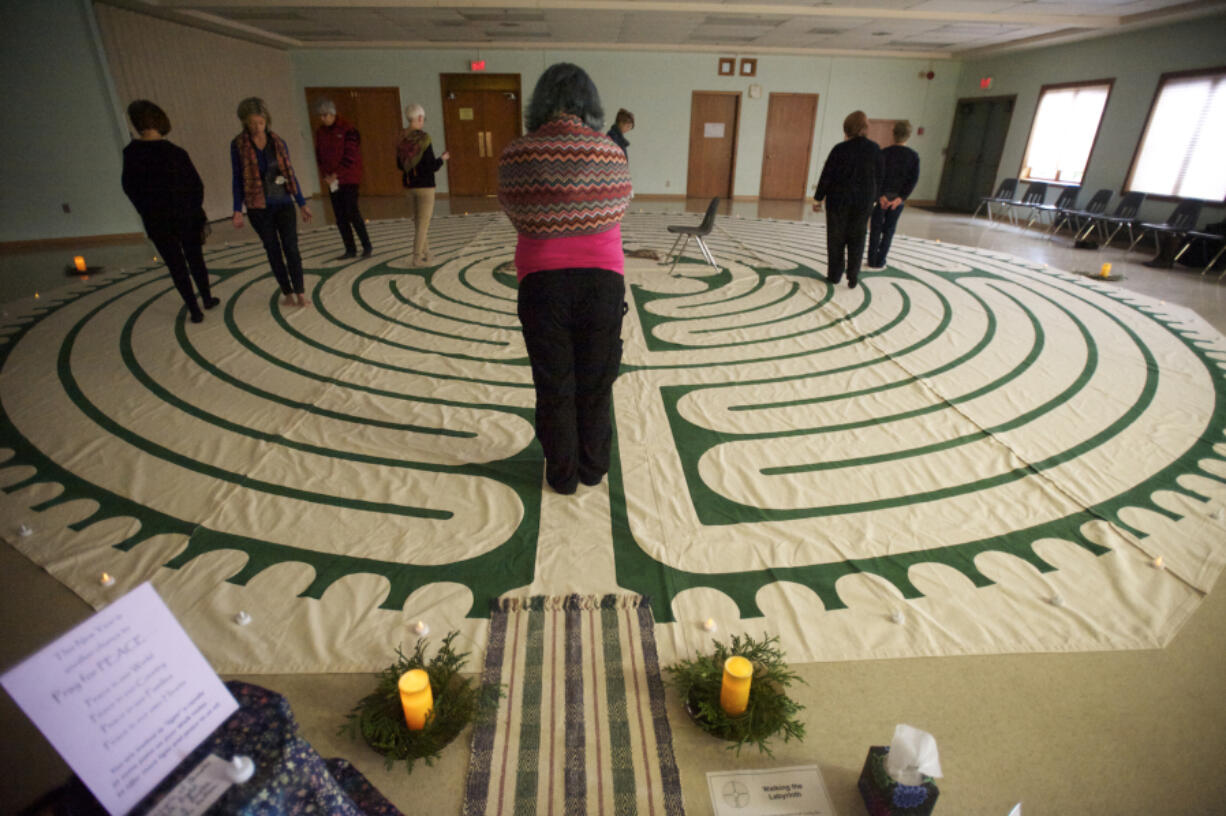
[292,49,959,198]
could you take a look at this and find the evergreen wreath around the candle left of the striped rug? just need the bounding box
[340,632,501,773]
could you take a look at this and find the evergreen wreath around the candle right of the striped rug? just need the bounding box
[666,633,804,756]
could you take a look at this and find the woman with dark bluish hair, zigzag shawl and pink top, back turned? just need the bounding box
[498,62,631,494]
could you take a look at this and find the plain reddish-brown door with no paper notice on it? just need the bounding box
[758,93,818,200]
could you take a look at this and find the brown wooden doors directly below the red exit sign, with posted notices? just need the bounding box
[440,74,522,196]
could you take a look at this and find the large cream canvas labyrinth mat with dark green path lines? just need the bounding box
[0,213,1226,671]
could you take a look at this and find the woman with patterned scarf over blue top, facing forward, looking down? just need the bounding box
[230,97,311,306]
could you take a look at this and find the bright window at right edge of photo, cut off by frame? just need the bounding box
[1127,69,1226,201]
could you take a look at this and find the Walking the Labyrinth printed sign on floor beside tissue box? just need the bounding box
[706,765,835,816]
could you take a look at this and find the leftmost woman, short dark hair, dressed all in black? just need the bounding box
[123,99,221,323]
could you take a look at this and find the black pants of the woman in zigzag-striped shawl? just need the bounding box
[519,270,625,493]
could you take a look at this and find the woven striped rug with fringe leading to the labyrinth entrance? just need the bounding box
[463,595,685,816]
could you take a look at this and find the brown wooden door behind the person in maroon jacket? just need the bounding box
[305,88,403,196]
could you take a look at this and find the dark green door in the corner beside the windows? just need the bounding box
[937,97,1015,212]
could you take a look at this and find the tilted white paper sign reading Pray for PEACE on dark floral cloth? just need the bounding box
[0,583,238,816]
